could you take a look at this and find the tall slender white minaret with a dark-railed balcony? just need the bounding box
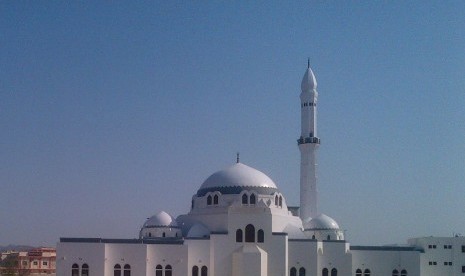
[297,60,320,220]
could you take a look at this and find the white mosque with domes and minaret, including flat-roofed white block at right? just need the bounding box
[57,62,465,276]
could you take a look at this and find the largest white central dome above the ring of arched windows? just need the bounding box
[197,163,277,194]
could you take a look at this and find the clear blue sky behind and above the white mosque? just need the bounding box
[0,1,465,245]
